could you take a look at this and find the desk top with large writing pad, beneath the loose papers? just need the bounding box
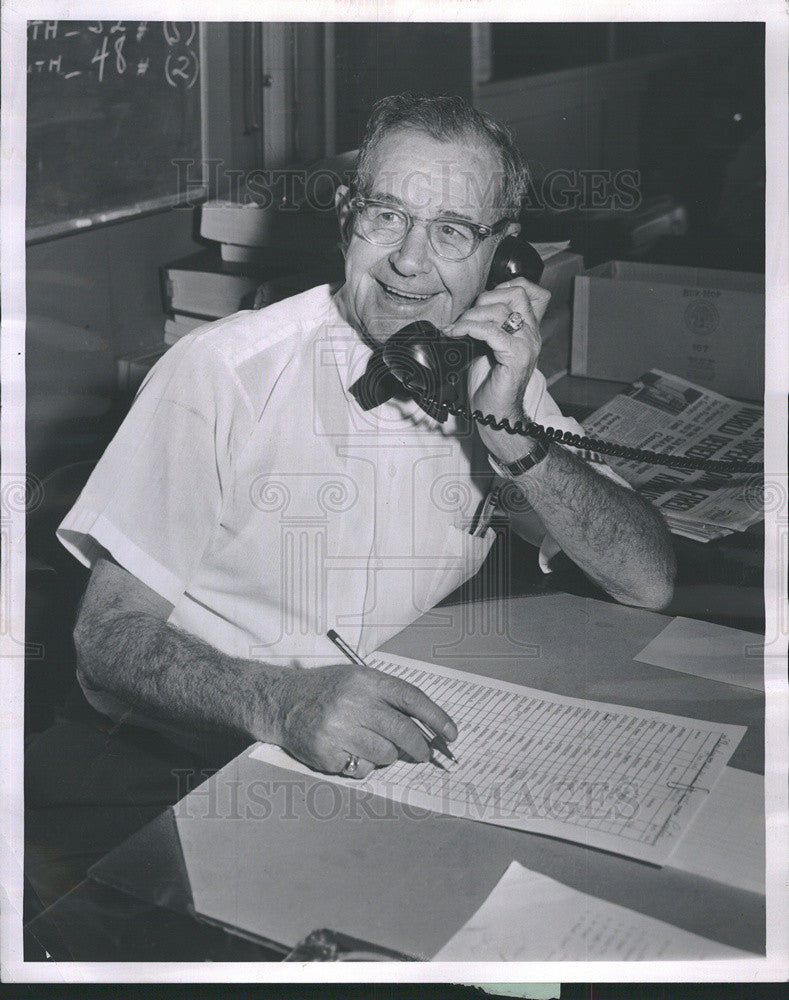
[24,593,764,959]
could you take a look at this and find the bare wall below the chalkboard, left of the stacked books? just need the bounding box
[26,209,197,477]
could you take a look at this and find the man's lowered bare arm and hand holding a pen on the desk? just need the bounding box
[74,559,457,778]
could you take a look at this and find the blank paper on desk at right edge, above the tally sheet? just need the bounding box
[633,618,764,691]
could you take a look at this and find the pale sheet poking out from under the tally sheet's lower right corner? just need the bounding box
[667,767,765,896]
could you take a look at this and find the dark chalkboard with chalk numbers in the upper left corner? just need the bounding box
[26,21,203,241]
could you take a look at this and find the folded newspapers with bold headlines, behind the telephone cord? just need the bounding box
[584,369,764,542]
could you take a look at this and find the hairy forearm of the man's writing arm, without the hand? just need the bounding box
[74,596,287,742]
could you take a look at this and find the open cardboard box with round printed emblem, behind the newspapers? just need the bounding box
[570,260,764,400]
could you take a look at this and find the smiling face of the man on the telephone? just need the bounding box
[338,130,508,344]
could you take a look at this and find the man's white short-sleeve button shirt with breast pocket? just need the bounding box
[58,286,628,728]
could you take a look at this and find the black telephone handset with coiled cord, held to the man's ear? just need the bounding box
[378,236,762,475]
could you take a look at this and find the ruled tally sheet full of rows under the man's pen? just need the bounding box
[250,654,745,864]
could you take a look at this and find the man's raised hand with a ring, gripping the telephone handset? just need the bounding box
[444,278,551,461]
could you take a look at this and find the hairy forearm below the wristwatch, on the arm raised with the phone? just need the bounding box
[518,445,676,609]
